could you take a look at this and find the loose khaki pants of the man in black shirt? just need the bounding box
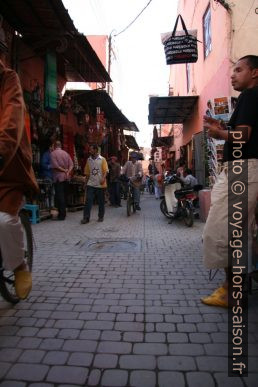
[203,159,258,272]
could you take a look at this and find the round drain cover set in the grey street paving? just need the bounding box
[81,240,141,253]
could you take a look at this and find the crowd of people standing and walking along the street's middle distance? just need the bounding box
[41,141,200,224]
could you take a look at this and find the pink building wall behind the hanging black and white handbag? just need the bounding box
[169,0,232,158]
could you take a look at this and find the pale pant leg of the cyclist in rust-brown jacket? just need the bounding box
[0,212,24,271]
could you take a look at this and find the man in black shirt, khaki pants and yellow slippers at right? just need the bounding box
[201,55,258,307]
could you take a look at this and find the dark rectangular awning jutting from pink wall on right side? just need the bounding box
[149,96,199,125]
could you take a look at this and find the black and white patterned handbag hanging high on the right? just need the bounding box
[162,15,198,65]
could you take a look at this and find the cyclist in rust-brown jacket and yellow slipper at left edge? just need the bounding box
[0,31,38,299]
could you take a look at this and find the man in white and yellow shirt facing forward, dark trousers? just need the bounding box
[81,145,108,224]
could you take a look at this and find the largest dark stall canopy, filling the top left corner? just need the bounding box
[0,0,111,82]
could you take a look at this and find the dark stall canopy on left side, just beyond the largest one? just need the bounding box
[66,90,139,132]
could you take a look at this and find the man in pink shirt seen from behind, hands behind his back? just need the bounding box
[50,141,73,220]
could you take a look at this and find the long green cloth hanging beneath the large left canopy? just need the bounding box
[44,52,57,111]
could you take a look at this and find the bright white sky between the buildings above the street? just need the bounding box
[62,0,177,147]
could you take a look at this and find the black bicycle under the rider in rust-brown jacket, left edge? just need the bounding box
[0,210,33,304]
